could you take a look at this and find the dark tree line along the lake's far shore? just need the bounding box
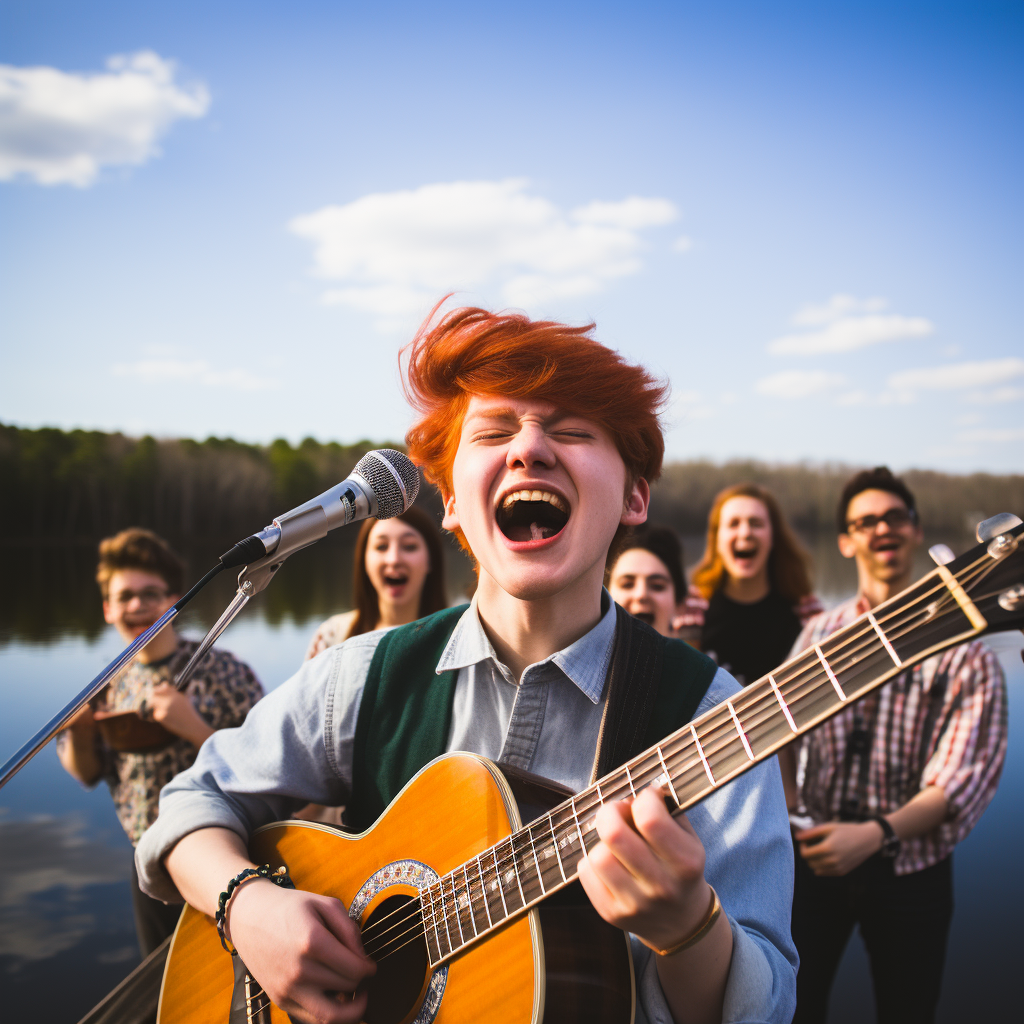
[0,424,1024,547]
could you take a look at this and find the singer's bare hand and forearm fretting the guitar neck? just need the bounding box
[579,786,732,1024]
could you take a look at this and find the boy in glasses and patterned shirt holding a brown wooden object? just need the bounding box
[57,527,263,956]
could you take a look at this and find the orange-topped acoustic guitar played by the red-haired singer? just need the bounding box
[158,524,1024,1024]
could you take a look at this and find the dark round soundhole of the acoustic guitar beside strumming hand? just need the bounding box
[362,895,430,1024]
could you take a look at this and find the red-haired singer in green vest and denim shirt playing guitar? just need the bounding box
[138,309,796,1024]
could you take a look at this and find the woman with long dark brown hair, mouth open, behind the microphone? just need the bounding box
[306,505,447,659]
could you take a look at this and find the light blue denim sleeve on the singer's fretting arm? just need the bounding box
[633,671,798,1024]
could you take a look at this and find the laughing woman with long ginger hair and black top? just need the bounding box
[691,483,821,686]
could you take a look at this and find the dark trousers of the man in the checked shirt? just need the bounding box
[793,850,953,1024]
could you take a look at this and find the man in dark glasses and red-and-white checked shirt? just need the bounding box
[779,466,1007,1024]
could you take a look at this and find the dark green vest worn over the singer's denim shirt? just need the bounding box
[345,605,718,831]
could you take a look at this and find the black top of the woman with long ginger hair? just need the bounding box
[700,590,800,686]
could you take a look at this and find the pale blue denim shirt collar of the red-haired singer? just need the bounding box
[435,590,615,705]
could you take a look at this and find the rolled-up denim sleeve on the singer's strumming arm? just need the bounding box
[135,634,380,902]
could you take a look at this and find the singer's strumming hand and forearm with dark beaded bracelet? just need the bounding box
[167,828,377,1024]
